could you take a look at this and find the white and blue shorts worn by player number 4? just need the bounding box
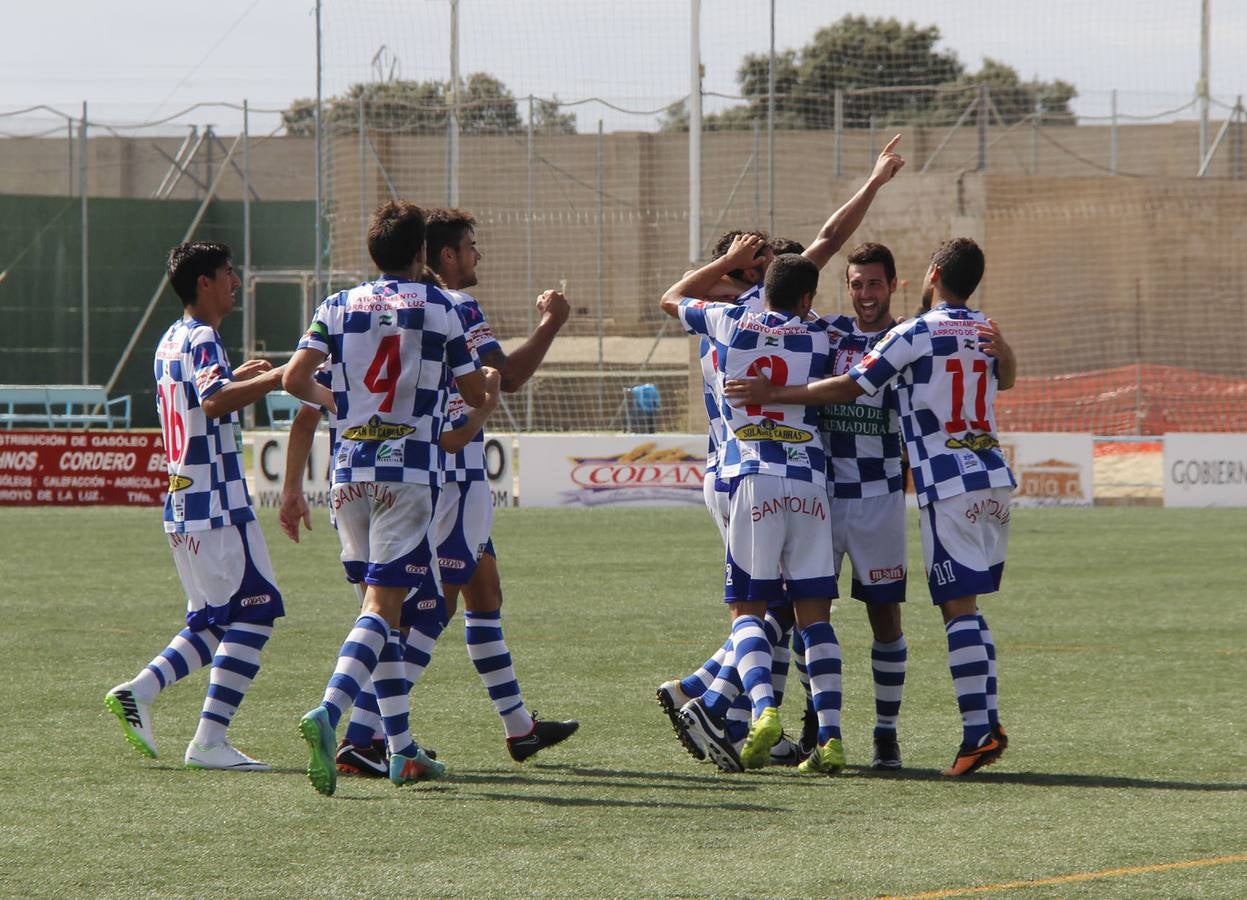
[329,481,436,587]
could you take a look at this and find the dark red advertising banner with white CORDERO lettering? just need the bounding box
[0,431,168,506]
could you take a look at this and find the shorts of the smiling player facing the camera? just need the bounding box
[832,491,907,603]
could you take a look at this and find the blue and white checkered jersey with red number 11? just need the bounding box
[848,304,1016,506]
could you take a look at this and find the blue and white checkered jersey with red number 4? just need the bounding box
[299,275,480,485]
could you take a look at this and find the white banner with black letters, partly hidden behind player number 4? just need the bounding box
[247,425,515,509]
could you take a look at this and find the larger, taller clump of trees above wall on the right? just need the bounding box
[660,15,1077,131]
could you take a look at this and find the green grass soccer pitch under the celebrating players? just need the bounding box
[0,509,1247,898]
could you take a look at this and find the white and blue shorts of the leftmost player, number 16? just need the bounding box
[167,521,286,631]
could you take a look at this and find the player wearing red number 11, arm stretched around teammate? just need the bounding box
[725,238,1018,777]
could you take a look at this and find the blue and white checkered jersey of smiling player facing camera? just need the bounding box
[819,315,905,497]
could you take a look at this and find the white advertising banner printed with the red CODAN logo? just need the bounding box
[518,434,706,506]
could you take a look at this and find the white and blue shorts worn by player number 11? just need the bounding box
[918,487,1013,603]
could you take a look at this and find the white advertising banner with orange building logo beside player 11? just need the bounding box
[1000,431,1095,506]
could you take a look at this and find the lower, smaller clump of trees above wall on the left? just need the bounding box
[282,72,576,136]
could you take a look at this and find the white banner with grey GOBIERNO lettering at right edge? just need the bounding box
[1165,434,1247,506]
